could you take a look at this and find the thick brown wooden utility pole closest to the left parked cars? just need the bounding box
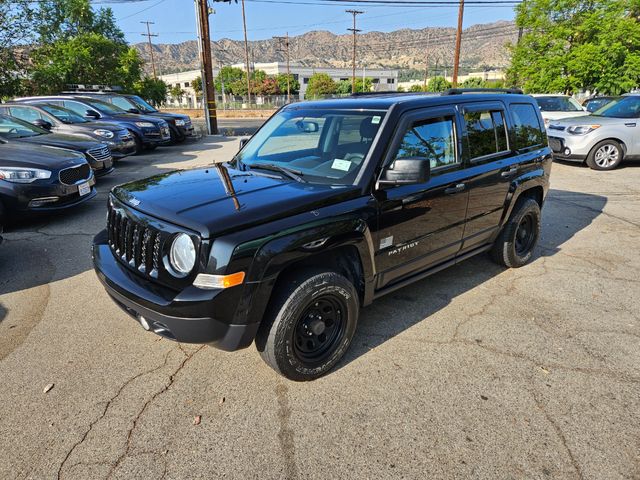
[196,0,218,135]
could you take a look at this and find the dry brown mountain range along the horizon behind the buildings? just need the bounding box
[135,21,518,73]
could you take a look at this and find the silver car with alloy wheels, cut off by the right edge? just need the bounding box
[547,94,640,170]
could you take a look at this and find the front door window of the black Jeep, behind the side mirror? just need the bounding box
[394,117,459,169]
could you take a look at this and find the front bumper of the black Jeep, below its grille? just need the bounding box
[92,231,259,351]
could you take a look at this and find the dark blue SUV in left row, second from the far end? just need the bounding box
[16,95,171,153]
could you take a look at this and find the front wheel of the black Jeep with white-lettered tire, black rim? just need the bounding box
[256,269,360,381]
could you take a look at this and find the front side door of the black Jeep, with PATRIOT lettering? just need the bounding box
[375,107,469,288]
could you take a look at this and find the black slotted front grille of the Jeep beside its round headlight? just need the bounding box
[107,205,162,278]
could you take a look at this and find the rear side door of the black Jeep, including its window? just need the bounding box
[460,102,519,253]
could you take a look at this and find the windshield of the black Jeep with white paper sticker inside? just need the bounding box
[232,109,385,185]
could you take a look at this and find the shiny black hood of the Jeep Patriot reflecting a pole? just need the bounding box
[113,164,360,238]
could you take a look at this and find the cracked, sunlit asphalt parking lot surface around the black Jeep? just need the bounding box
[0,137,640,479]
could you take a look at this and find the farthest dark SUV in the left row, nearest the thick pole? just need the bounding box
[69,92,195,143]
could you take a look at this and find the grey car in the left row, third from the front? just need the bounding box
[0,103,136,159]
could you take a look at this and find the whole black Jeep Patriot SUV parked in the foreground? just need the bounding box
[93,90,551,380]
